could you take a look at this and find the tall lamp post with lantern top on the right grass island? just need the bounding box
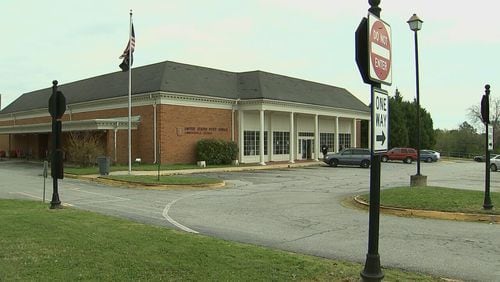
[407,14,427,186]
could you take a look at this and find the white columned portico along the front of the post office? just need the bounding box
[237,100,369,165]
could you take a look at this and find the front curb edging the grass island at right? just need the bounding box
[353,195,500,224]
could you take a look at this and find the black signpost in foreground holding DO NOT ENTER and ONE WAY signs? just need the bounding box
[355,0,392,281]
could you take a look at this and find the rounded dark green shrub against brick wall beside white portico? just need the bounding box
[196,139,238,165]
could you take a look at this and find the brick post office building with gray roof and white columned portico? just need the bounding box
[0,61,370,164]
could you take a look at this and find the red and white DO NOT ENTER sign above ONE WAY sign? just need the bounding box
[368,15,392,85]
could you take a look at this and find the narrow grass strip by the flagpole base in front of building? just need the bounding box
[101,175,223,185]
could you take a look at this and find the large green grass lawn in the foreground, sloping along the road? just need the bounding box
[0,200,446,281]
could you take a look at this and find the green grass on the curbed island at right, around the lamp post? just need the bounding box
[361,186,500,214]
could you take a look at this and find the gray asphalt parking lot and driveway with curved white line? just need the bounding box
[0,161,500,281]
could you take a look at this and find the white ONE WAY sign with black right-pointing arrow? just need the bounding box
[372,87,389,153]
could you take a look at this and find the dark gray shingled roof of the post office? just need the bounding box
[0,61,369,114]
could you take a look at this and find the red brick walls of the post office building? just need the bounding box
[0,105,238,164]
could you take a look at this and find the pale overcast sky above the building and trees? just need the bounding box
[0,0,500,129]
